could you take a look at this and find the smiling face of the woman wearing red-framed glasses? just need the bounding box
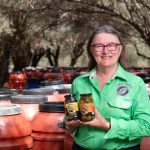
[91,33,123,68]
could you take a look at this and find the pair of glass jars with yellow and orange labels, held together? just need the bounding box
[65,94,95,122]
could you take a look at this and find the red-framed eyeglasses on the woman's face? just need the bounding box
[91,43,122,52]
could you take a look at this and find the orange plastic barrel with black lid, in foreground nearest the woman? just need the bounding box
[31,102,65,150]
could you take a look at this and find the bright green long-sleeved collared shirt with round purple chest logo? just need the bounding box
[71,65,150,150]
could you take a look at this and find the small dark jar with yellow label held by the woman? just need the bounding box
[64,94,79,121]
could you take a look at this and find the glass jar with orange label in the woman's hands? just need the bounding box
[79,94,95,122]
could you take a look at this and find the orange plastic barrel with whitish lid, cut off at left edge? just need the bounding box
[0,104,33,150]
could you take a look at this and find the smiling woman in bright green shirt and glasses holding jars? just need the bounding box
[66,25,150,150]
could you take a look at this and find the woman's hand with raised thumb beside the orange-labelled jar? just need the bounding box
[80,108,110,131]
